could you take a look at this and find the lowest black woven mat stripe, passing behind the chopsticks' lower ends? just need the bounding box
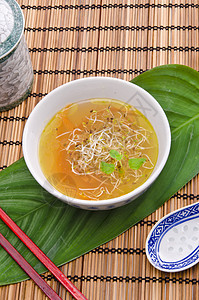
[41,275,199,285]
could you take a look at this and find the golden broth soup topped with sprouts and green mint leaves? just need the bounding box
[39,99,158,200]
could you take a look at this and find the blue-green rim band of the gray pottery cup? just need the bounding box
[0,0,24,63]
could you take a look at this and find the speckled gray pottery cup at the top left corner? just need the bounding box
[0,0,33,111]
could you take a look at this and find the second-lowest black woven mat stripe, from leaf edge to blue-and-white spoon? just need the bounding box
[91,247,146,255]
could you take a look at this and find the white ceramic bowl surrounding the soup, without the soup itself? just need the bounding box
[23,77,171,210]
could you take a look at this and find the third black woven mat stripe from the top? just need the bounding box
[29,46,199,52]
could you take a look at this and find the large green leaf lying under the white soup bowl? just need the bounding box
[0,65,199,285]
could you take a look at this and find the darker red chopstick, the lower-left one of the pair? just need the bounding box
[0,233,61,300]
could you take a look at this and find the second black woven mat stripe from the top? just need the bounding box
[25,25,199,32]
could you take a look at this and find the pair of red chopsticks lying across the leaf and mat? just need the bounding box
[0,208,87,300]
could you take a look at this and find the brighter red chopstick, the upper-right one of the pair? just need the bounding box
[0,208,87,300]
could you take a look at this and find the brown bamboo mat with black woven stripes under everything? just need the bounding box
[0,0,199,300]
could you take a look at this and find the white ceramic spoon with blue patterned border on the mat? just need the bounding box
[146,203,199,272]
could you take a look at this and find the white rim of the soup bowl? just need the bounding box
[22,76,171,208]
